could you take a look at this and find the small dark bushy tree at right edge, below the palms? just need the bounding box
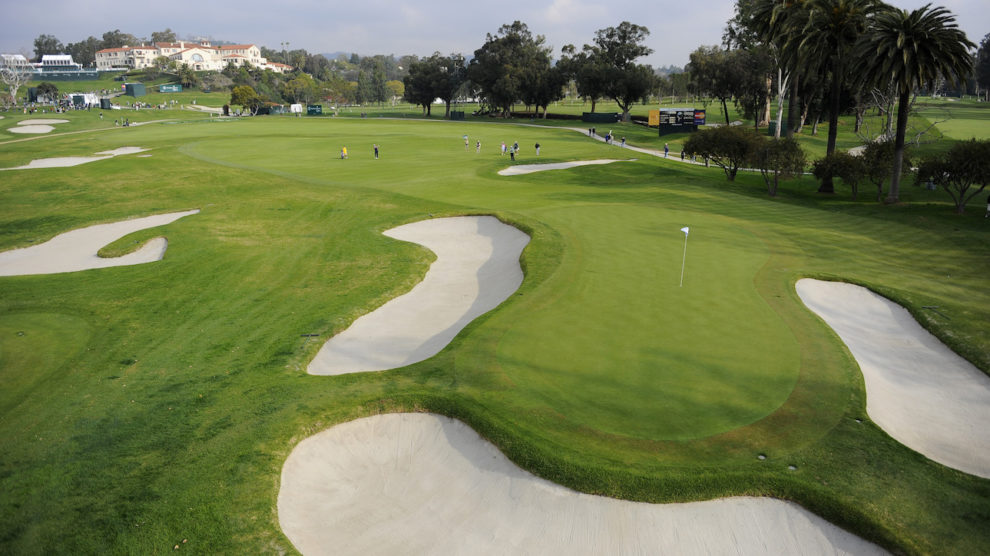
[915,139,990,214]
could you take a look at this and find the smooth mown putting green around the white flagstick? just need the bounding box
[498,205,800,440]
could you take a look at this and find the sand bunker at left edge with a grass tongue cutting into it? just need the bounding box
[0,209,199,276]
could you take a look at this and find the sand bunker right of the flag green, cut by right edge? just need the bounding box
[796,279,990,478]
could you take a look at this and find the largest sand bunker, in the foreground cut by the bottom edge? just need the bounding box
[278,414,883,555]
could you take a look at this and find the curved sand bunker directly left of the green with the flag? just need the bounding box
[306,216,529,375]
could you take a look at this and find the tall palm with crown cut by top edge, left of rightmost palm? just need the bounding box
[789,0,882,193]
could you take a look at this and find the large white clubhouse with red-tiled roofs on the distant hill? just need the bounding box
[96,41,292,73]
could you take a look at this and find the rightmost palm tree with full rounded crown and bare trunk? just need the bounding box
[857,4,976,203]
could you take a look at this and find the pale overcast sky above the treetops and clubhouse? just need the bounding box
[0,0,990,66]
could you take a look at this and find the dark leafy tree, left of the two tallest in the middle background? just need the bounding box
[467,21,550,117]
